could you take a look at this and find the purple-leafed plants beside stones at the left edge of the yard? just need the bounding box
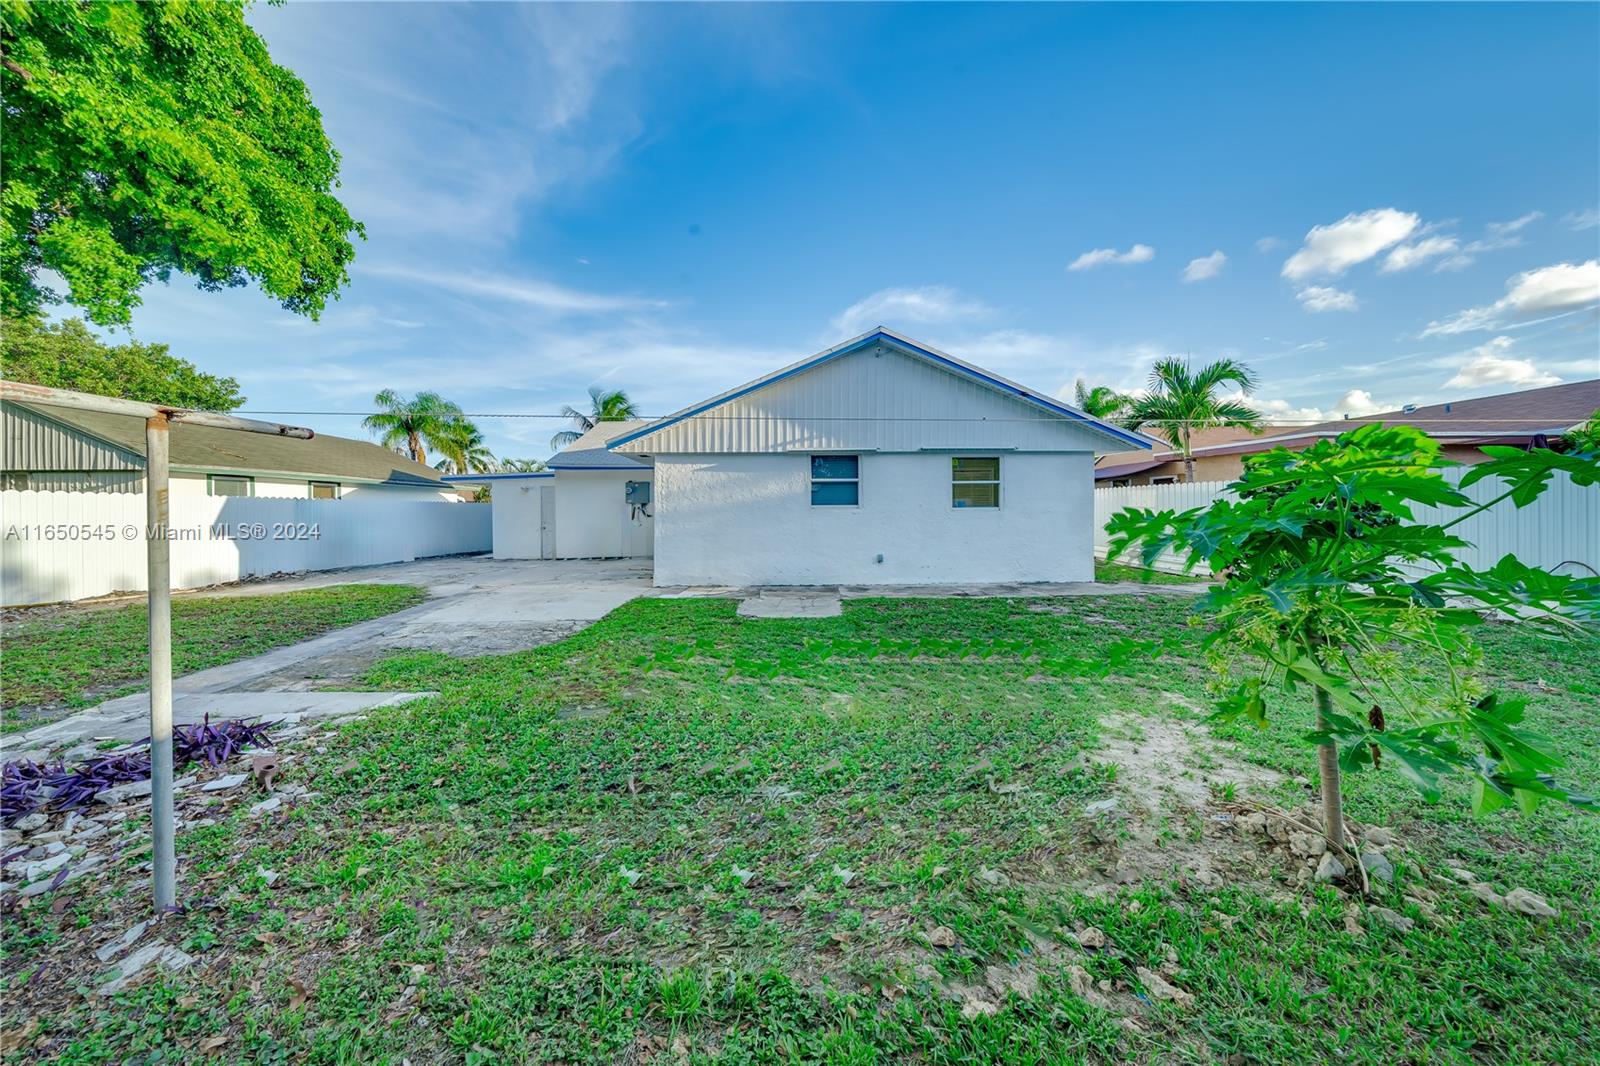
[3,715,277,823]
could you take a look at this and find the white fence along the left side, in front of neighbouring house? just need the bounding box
[0,491,493,607]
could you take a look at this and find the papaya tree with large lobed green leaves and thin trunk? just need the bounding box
[1107,426,1600,848]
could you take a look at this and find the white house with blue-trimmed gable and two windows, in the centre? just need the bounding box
[604,330,1157,586]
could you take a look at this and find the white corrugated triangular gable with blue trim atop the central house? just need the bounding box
[610,328,1157,455]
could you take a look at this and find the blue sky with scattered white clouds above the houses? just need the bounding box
[109,3,1600,456]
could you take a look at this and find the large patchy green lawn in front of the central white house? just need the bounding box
[0,597,1600,1063]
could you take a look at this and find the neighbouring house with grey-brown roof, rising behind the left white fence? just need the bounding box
[0,400,458,501]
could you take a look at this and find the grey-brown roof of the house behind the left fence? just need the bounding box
[5,402,445,488]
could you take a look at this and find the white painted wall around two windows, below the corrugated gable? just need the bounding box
[649,451,1094,586]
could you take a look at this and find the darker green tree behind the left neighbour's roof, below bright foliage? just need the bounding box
[0,319,245,411]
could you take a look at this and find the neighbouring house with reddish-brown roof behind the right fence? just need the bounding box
[1094,379,1600,488]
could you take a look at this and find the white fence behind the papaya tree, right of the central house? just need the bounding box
[1094,471,1600,576]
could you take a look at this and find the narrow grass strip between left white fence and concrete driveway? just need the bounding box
[0,584,427,731]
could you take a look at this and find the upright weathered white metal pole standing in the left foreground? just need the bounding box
[144,415,178,911]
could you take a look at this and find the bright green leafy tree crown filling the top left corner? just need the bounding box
[0,0,362,325]
